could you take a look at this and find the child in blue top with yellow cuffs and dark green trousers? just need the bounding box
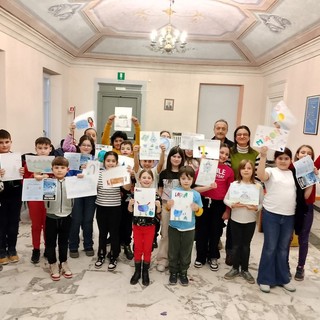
[166,166,203,286]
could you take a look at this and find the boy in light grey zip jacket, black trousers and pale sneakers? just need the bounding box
[45,157,73,281]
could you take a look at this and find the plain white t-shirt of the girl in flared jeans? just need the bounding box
[263,168,296,216]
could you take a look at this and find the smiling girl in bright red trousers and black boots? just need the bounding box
[128,169,161,286]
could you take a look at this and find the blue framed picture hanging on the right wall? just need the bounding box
[303,95,320,135]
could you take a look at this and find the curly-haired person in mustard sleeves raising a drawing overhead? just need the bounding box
[101,114,140,154]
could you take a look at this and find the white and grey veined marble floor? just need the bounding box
[0,211,320,320]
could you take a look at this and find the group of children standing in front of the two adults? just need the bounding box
[0,122,320,292]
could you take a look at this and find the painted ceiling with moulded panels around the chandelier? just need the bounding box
[0,0,320,66]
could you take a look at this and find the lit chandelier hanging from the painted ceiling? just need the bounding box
[150,0,187,54]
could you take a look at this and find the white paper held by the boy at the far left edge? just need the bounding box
[0,152,22,181]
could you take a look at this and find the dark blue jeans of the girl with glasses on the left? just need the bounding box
[69,196,96,251]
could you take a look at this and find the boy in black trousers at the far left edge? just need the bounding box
[0,129,24,265]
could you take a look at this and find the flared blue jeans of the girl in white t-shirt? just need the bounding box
[257,208,294,286]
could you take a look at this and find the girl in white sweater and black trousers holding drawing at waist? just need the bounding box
[224,160,263,284]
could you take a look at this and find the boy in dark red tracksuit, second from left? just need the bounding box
[23,137,52,263]
